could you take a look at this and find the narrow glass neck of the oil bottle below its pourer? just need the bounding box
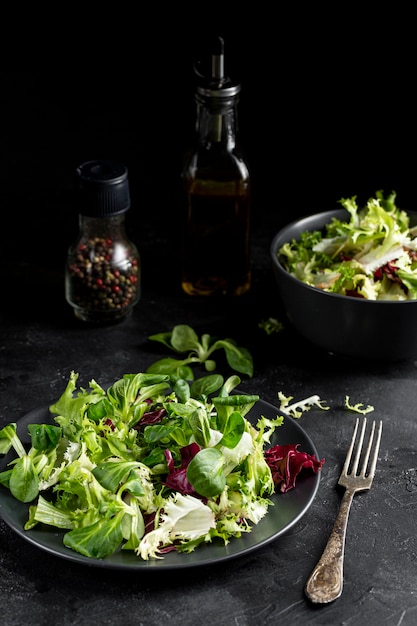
[196,94,238,151]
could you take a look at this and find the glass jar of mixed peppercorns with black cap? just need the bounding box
[65,160,141,324]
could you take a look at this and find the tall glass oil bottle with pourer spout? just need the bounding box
[181,37,251,296]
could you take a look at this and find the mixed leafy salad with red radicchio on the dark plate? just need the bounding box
[0,372,324,560]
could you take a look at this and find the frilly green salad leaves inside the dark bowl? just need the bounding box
[278,191,417,300]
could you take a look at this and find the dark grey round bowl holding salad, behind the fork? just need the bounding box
[270,209,417,361]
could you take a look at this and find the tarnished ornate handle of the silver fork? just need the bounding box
[304,489,354,604]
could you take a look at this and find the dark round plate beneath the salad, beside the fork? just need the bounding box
[0,400,320,570]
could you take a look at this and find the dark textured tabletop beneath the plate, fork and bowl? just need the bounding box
[0,201,417,626]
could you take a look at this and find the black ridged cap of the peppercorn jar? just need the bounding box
[76,160,130,217]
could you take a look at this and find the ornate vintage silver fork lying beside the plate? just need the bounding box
[304,417,382,604]
